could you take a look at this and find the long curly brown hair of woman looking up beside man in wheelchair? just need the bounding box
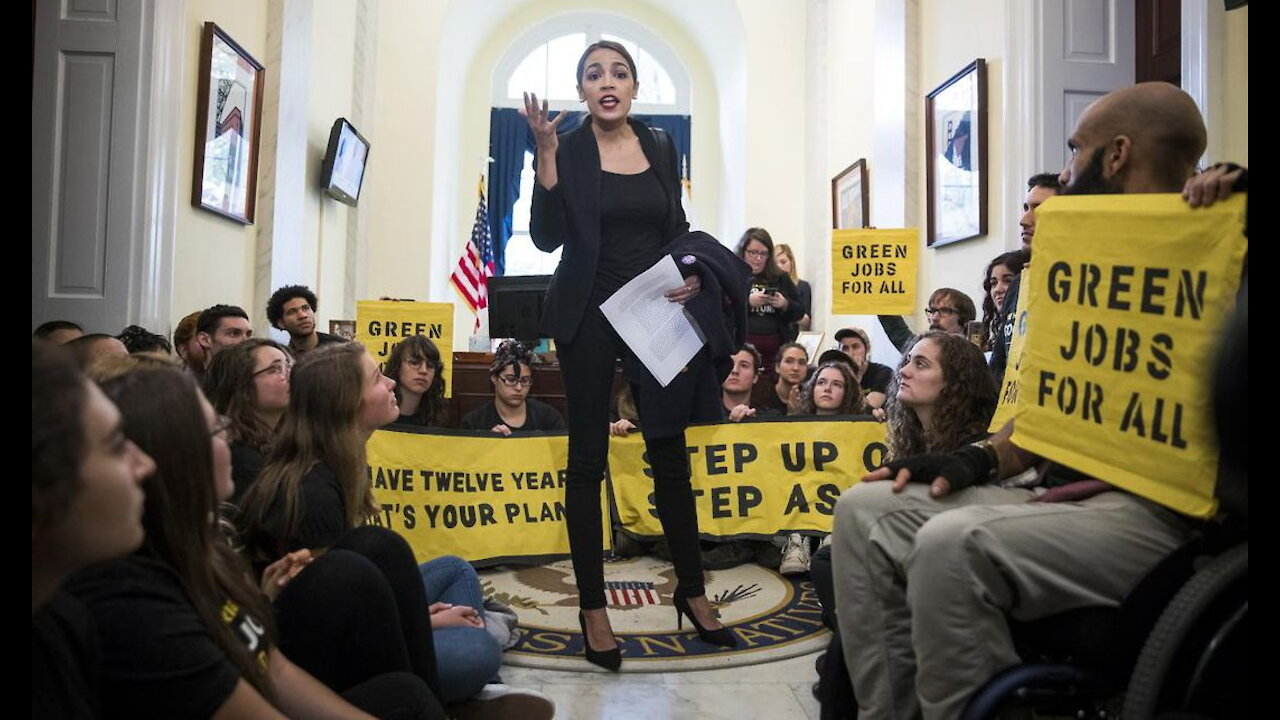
[884,331,997,460]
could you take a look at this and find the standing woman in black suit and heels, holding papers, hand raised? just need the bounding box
[525,41,735,670]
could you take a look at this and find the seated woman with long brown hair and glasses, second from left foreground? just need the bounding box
[69,355,444,717]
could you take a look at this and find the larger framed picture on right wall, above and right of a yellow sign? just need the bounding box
[924,58,987,246]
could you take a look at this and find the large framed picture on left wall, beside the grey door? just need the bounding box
[191,23,264,224]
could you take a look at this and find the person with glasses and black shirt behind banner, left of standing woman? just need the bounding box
[461,342,564,436]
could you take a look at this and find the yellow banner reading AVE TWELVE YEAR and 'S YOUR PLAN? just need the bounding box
[366,429,609,565]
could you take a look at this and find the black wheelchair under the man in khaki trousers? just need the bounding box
[814,534,1249,720]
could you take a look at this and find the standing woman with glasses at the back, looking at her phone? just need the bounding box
[737,228,805,368]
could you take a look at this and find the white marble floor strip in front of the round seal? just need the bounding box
[502,653,818,720]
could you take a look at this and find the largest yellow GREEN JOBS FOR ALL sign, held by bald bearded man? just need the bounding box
[1014,195,1248,516]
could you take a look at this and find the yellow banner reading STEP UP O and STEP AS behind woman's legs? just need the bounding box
[609,419,886,538]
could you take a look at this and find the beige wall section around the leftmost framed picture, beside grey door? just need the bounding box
[172,0,266,324]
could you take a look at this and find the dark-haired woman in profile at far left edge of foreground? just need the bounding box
[31,340,155,717]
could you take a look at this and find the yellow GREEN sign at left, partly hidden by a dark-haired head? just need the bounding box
[356,300,453,397]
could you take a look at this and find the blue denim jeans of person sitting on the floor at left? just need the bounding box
[419,555,502,703]
